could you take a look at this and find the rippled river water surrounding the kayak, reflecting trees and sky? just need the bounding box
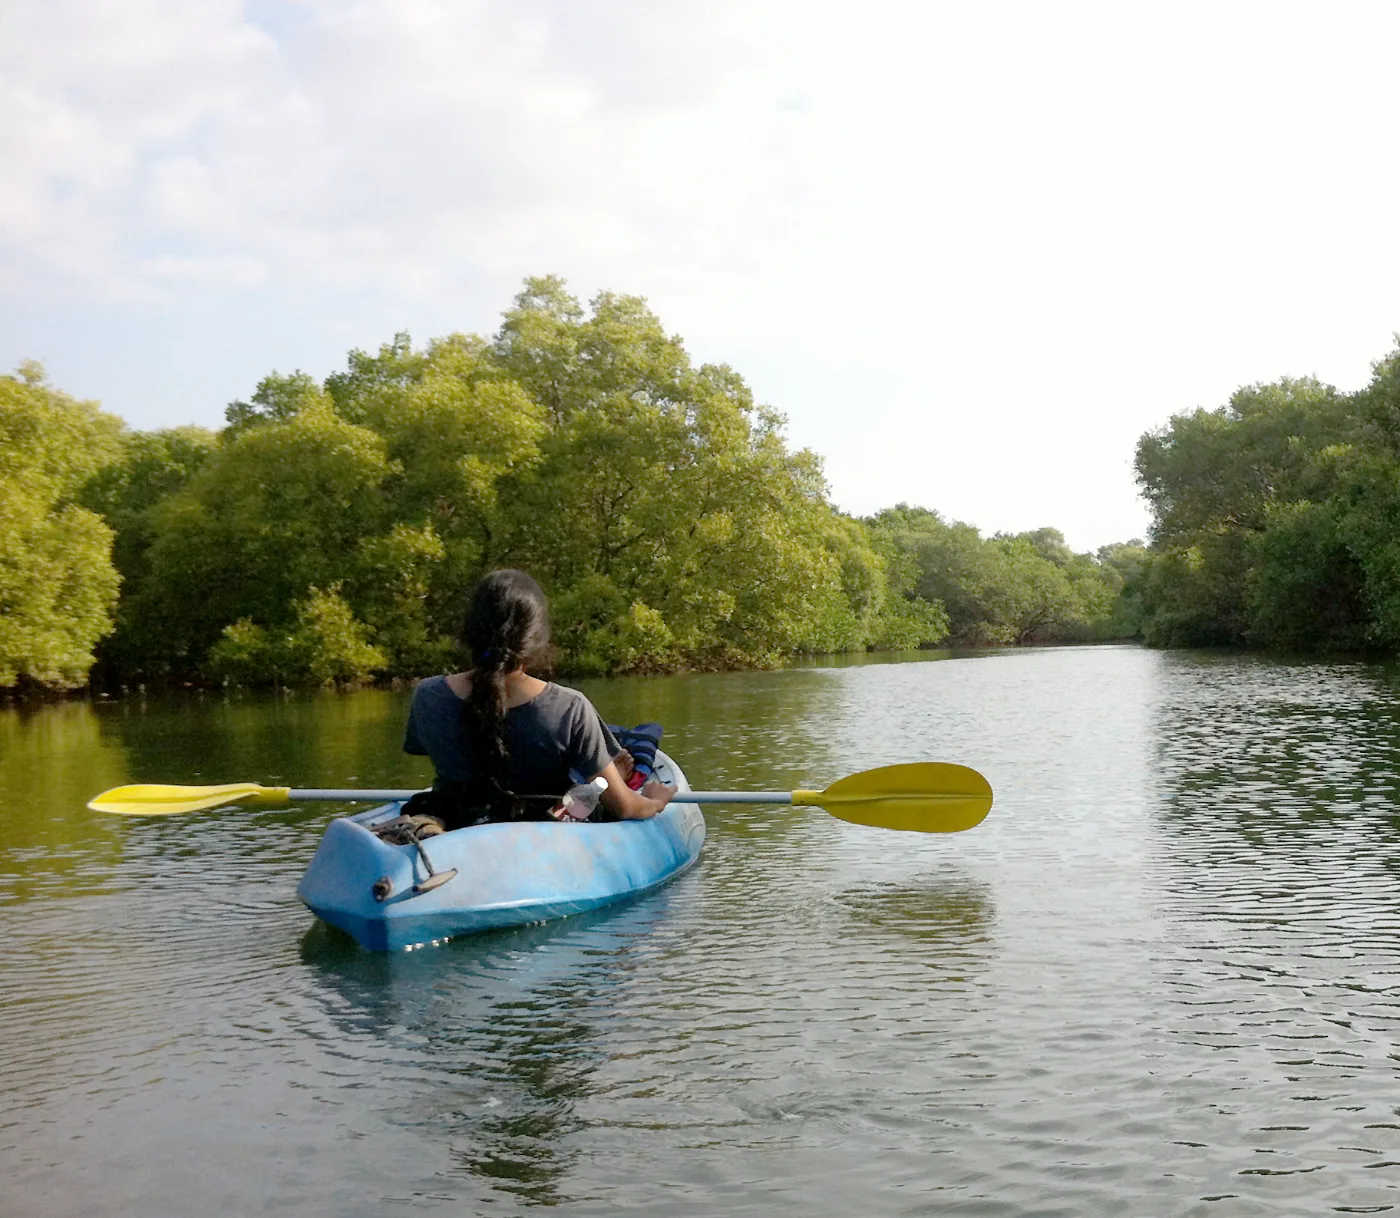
[0,647,1400,1218]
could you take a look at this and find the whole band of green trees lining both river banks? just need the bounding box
[0,277,1400,699]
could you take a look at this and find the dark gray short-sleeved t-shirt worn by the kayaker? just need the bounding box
[403,676,622,795]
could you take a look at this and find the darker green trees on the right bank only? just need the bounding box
[1137,341,1400,654]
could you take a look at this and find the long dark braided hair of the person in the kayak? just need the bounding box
[462,571,549,802]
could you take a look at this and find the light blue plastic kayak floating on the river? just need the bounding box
[297,752,704,951]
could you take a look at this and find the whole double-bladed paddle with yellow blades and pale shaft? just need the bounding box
[88,762,991,833]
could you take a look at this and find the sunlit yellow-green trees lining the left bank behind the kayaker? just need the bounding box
[0,277,1140,686]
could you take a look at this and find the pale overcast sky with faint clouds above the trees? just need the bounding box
[0,0,1400,550]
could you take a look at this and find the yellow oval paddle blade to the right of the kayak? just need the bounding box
[792,762,991,833]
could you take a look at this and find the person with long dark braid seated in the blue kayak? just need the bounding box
[403,570,676,829]
